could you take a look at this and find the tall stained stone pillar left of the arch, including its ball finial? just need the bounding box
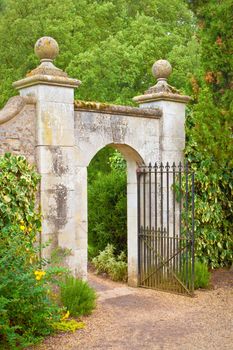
[13,37,80,274]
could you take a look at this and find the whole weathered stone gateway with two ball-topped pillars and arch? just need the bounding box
[0,37,189,286]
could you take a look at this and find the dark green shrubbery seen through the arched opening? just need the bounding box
[88,148,127,255]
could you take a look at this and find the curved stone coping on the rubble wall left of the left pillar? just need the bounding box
[0,96,36,125]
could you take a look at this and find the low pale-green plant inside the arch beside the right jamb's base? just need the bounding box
[92,244,127,281]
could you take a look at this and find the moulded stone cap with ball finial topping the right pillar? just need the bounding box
[133,60,190,103]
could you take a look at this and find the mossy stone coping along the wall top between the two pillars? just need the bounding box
[74,100,162,119]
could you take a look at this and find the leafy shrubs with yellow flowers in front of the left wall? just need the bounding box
[0,154,65,349]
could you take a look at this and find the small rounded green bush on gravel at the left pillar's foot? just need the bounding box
[60,276,96,316]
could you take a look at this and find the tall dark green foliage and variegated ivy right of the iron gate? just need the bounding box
[186,0,233,268]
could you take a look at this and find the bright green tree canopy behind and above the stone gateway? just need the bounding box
[0,0,199,105]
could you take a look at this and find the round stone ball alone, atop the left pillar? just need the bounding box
[34,36,59,62]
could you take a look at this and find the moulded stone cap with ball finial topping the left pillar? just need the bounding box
[13,36,81,89]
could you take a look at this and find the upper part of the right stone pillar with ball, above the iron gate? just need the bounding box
[133,60,190,164]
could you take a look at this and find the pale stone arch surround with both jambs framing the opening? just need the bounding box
[76,143,144,286]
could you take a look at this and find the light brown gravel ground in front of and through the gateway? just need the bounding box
[35,270,233,350]
